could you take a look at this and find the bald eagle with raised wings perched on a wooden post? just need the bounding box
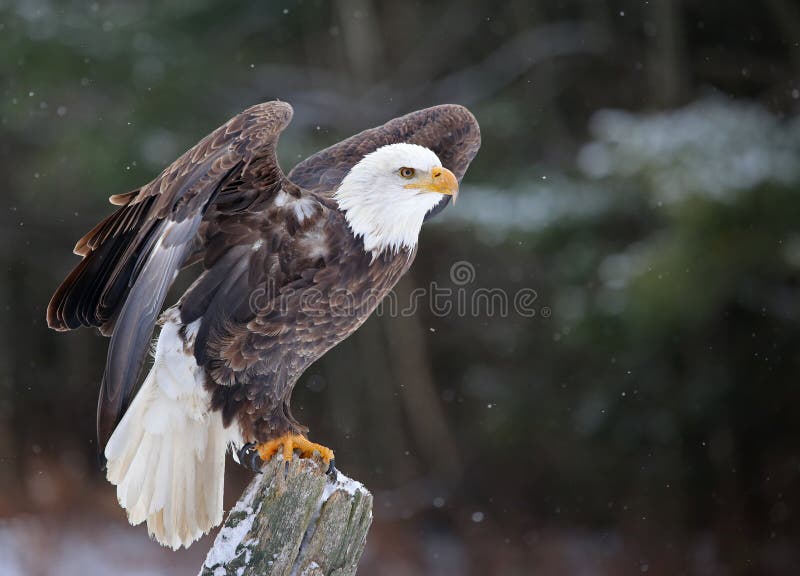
[47,102,480,549]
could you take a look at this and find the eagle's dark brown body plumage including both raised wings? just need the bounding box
[47,102,480,447]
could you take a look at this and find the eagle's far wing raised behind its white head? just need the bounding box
[288,104,481,217]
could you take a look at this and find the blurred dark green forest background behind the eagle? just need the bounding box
[0,0,800,576]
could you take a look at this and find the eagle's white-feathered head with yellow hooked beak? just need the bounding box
[334,144,458,254]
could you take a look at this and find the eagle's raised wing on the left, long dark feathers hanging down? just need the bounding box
[47,102,292,448]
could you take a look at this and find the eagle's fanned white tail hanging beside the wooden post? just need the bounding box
[105,310,239,549]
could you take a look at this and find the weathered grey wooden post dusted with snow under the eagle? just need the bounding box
[200,457,372,576]
